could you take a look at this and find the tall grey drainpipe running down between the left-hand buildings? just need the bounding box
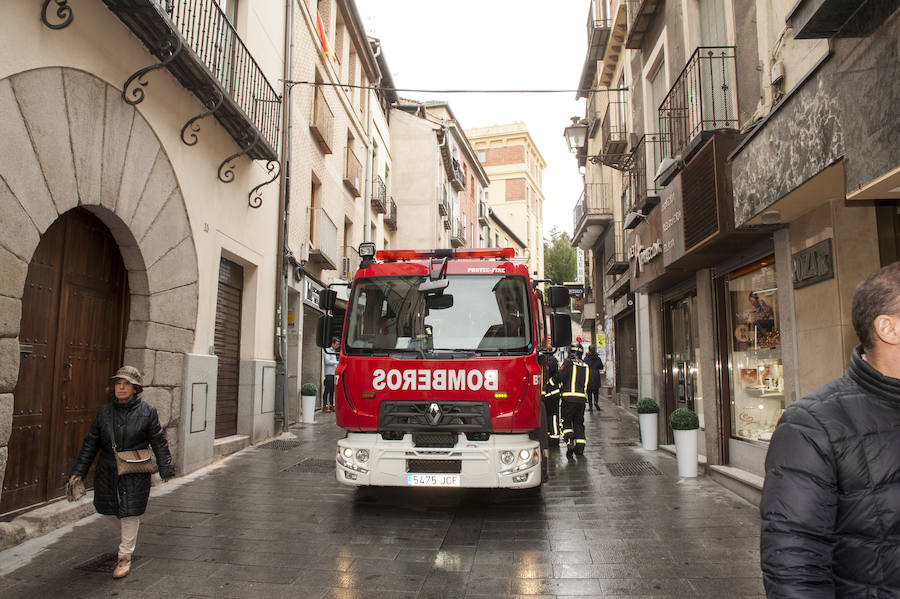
[275,0,295,432]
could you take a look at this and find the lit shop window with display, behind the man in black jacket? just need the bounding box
[726,257,784,441]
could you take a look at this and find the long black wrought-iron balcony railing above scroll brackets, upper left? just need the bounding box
[104,0,281,160]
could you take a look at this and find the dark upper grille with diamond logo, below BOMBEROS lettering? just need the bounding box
[378,401,491,432]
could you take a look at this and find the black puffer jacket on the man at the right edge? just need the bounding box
[760,348,900,599]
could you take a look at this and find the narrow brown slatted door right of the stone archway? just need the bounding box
[214,258,244,439]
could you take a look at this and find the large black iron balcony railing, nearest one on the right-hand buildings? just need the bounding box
[659,46,739,161]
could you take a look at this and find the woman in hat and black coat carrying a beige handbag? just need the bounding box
[69,366,175,578]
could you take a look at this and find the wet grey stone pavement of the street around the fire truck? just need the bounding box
[0,404,764,599]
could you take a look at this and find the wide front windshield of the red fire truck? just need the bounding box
[344,275,533,357]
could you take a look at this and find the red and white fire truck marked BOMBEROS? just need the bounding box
[317,243,572,488]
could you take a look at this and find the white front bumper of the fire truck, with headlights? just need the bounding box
[335,433,542,489]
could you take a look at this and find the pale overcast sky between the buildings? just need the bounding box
[356,0,590,238]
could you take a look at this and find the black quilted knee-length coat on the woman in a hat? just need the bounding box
[71,395,175,518]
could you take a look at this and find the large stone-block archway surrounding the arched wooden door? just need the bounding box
[0,67,198,510]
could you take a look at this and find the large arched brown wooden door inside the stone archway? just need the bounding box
[0,209,128,513]
